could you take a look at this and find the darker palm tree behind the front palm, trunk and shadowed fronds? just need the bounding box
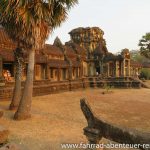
[0,12,24,110]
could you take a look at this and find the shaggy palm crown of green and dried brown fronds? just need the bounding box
[0,0,77,48]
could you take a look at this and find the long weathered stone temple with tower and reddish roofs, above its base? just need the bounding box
[0,27,141,81]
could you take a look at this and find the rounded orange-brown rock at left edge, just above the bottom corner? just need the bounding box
[0,126,9,144]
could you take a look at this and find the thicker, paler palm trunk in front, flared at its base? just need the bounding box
[14,50,35,120]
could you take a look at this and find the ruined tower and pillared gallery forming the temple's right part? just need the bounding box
[69,27,141,77]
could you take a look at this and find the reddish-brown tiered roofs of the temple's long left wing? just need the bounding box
[0,28,85,67]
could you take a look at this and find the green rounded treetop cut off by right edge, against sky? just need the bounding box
[139,32,150,59]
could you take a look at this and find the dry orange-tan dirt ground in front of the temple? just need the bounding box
[0,89,150,150]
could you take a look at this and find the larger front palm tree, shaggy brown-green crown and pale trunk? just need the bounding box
[0,0,77,120]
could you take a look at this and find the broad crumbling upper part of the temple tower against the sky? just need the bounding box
[69,27,107,56]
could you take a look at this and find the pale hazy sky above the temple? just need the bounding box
[47,0,150,53]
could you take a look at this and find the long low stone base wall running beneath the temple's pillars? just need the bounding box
[0,77,141,100]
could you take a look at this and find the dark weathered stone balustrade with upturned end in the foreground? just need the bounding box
[80,99,150,150]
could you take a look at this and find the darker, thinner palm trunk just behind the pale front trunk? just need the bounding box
[9,48,23,110]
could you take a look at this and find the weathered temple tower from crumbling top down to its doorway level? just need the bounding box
[69,27,108,76]
